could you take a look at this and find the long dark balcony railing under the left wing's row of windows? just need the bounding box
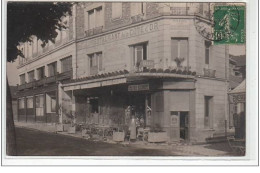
[17,70,72,91]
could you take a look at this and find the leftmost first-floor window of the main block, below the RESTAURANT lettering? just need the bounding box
[88,52,102,75]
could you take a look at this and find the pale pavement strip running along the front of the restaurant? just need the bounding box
[15,122,237,156]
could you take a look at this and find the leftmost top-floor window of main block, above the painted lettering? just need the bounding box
[87,6,104,29]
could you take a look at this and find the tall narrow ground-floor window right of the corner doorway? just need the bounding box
[204,96,213,128]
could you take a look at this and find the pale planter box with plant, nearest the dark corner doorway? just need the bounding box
[148,124,167,142]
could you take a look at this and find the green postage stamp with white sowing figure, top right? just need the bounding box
[213,5,245,44]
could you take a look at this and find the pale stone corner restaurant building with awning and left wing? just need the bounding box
[17,2,229,142]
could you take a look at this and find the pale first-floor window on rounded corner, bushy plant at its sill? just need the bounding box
[171,38,188,68]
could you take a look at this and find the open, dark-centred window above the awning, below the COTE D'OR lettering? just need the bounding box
[133,43,147,71]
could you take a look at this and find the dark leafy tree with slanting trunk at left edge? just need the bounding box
[6,2,73,155]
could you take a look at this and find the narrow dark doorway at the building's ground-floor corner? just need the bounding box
[180,112,189,140]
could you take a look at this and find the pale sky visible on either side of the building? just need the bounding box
[6,45,246,86]
